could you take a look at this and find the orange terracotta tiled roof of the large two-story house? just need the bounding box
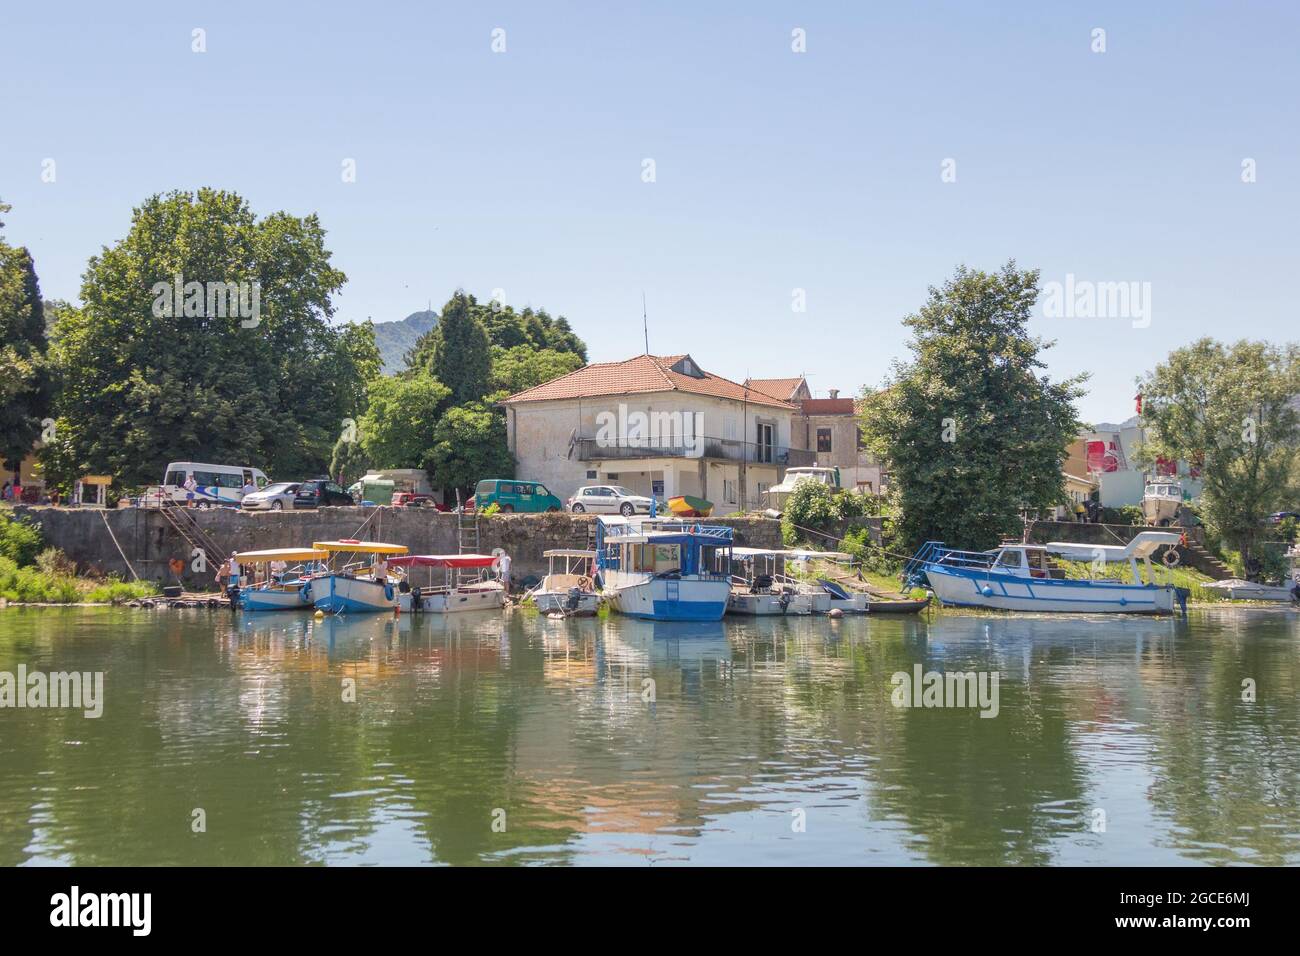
[504,355,796,410]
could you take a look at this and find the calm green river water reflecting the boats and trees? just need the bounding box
[0,609,1300,865]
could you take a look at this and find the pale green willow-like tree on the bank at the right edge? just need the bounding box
[1139,338,1300,561]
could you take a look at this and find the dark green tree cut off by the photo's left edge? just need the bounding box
[0,203,53,486]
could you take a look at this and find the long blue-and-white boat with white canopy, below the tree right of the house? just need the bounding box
[904,531,1188,614]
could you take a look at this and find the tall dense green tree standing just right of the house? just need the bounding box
[862,261,1086,548]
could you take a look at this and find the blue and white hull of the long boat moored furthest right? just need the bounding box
[924,563,1177,614]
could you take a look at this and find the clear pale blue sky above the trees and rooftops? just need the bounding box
[0,0,1300,420]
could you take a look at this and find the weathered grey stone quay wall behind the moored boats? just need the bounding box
[16,507,781,588]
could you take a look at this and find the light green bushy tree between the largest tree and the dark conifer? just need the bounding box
[358,375,451,468]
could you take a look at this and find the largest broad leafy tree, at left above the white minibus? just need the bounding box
[51,189,380,485]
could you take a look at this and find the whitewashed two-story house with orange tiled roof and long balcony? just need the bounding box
[503,355,813,515]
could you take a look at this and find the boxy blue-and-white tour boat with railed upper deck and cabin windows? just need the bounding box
[595,519,733,620]
